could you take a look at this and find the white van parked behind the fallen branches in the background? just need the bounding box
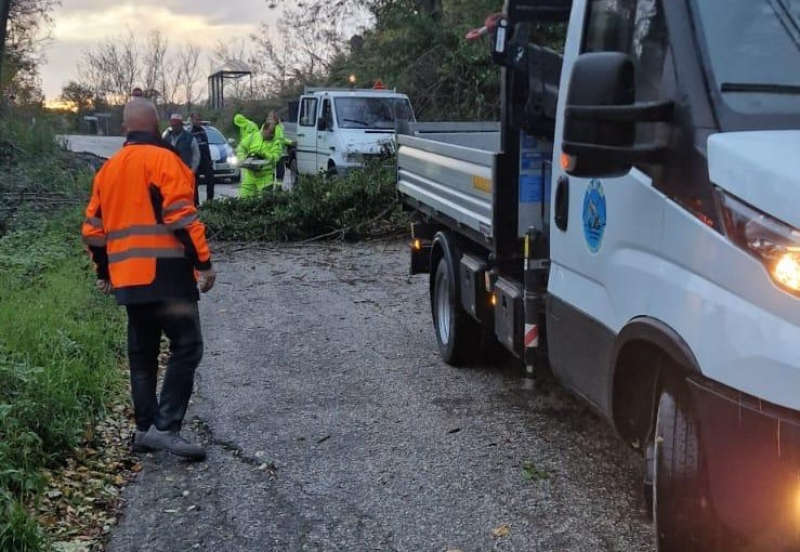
[284,88,415,179]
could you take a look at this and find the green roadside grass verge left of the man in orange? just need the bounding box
[0,125,124,552]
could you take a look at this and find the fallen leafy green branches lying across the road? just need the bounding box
[202,159,405,241]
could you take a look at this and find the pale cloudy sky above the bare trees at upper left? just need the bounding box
[41,0,279,99]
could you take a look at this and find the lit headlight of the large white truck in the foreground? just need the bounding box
[720,192,800,295]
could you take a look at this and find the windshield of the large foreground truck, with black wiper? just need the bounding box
[694,0,800,114]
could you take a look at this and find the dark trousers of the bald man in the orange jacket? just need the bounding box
[127,301,203,431]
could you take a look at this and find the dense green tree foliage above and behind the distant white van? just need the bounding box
[266,0,502,120]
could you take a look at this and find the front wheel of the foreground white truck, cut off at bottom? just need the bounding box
[652,385,722,552]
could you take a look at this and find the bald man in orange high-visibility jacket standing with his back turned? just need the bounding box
[83,98,216,460]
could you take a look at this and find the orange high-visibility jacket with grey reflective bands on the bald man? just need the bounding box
[82,132,211,305]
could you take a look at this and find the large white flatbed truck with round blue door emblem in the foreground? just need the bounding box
[404,0,800,552]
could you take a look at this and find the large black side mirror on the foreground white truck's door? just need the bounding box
[562,52,675,177]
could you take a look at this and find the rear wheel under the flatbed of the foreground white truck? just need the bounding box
[431,256,480,366]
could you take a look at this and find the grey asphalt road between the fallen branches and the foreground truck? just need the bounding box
[109,242,654,552]
